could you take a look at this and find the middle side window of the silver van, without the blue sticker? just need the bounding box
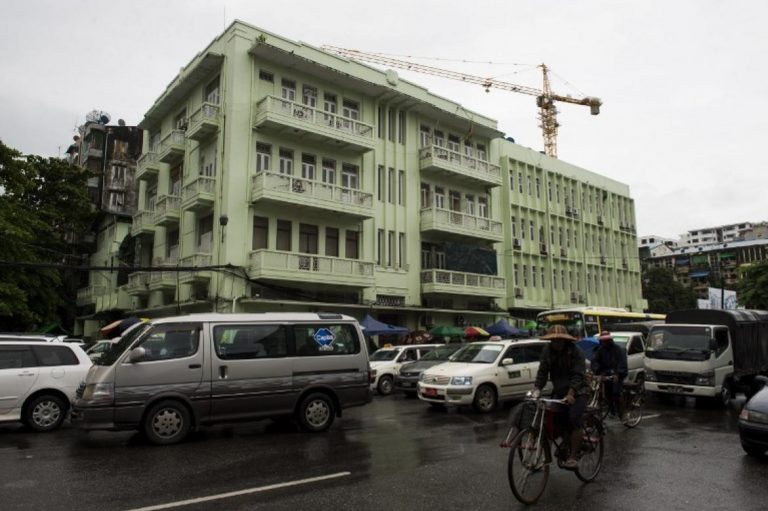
[213,325,288,360]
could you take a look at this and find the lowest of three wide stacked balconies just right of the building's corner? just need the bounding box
[248,249,374,287]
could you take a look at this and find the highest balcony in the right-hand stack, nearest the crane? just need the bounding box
[419,145,501,186]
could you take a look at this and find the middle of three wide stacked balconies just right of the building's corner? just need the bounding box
[251,172,373,219]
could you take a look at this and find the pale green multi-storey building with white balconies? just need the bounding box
[75,21,644,340]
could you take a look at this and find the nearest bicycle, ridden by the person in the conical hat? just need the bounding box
[501,398,603,504]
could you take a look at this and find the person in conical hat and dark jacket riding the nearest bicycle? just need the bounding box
[533,325,589,469]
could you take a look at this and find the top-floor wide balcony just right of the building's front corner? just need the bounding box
[254,96,376,153]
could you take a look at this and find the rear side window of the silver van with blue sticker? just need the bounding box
[293,323,360,357]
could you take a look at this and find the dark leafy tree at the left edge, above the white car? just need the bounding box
[0,141,93,331]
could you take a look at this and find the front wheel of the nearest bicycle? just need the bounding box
[507,428,549,504]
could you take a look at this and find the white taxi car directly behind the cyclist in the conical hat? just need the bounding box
[418,340,551,413]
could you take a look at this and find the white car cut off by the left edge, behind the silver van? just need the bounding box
[0,340,91,431]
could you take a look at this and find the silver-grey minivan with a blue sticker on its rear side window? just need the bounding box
[72,313,372,444]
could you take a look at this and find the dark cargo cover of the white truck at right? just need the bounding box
[664,309,768,376]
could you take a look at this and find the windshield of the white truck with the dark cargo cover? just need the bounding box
[645,325,712,360]
